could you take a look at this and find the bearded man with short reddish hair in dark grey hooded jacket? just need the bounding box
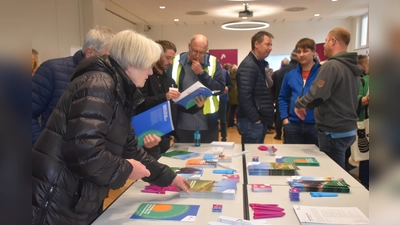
[295,27,363,168]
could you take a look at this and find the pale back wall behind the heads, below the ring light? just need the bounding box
[144,19,353,63]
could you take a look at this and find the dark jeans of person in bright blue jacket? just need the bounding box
[283,122,319,146]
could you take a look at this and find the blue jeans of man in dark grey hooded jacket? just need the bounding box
[318,130,356,169]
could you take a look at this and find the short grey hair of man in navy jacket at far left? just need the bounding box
[82,26,115,52]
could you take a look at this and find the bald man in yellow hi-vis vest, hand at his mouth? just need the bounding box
[168,34,225,143]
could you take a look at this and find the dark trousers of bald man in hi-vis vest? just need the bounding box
[175,127,219,143]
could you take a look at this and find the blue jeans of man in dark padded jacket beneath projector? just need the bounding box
[237,118,267,144]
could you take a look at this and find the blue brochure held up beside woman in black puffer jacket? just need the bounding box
[131,101,174,146]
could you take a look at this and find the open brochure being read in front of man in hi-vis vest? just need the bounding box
[172,81,220,109]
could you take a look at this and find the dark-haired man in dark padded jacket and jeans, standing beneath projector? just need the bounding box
[236,31,274,143]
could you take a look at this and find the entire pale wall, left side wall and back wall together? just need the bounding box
[32,0,355,65]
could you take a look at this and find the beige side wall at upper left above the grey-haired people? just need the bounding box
[32,0,136,62]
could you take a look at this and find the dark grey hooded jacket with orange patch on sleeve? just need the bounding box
[295,52,362,133]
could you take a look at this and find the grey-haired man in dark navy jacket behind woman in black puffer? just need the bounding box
[32,27,114,147]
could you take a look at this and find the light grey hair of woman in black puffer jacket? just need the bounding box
[109,30,163,70]
